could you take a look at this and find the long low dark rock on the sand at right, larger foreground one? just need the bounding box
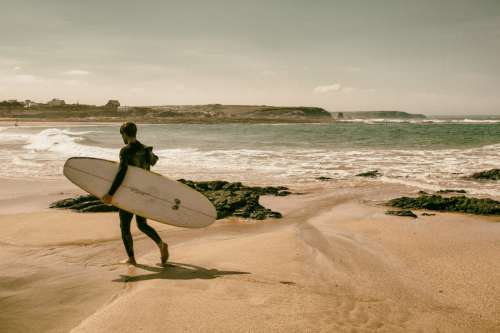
[386,194,500,215]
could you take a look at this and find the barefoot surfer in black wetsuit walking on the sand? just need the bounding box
[102,122,169,265]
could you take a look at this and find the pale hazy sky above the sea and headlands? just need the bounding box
[0,0,500,115]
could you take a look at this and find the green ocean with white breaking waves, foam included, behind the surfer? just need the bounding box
[0,119,500,196]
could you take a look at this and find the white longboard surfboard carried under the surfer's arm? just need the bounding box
[63,157,217,228]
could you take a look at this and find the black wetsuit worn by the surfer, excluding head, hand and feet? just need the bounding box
[108,141,161,257]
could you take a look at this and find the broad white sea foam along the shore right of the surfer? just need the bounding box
[150,145,500,195]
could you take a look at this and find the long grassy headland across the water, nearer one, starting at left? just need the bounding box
[0,102,333,123]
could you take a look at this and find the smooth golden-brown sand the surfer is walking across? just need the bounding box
[0,180,500,333]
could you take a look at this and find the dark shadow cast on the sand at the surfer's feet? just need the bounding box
[113,262,250,282]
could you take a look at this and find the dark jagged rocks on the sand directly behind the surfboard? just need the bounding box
[50,179,291,220]
